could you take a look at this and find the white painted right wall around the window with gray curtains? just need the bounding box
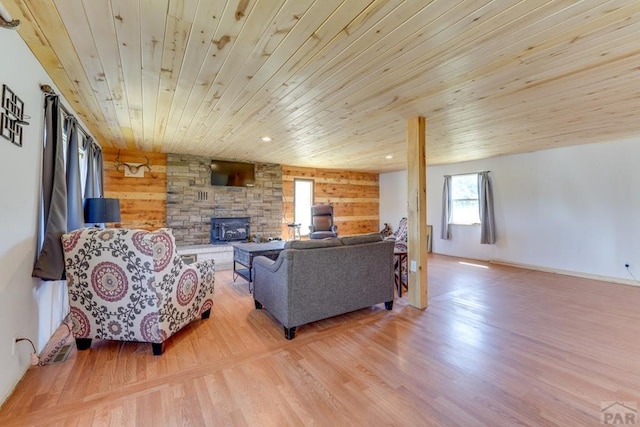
[380,138,640,281]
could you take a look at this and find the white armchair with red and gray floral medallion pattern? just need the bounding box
[62,228,215,355]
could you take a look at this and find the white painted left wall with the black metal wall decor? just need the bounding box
[0,29,86,402]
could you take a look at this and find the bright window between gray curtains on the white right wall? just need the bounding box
[451,173,480,225]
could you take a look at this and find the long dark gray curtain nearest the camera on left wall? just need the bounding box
[32,95,67,280]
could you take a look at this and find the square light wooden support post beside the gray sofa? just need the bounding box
[407,117,428,309]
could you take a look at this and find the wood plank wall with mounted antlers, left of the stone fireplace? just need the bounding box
[102,148,167,230]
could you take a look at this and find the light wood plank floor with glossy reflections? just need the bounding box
[0,255,640,427]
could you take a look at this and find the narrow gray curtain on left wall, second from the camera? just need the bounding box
[65,117,84,231]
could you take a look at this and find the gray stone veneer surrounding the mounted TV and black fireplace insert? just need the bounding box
[167,154,282,246]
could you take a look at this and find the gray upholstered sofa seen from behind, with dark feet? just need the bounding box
[253,233,395,339]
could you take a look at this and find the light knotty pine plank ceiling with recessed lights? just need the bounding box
[3,0,640,172]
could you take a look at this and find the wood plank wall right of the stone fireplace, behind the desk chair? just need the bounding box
[282,166,380,237]
